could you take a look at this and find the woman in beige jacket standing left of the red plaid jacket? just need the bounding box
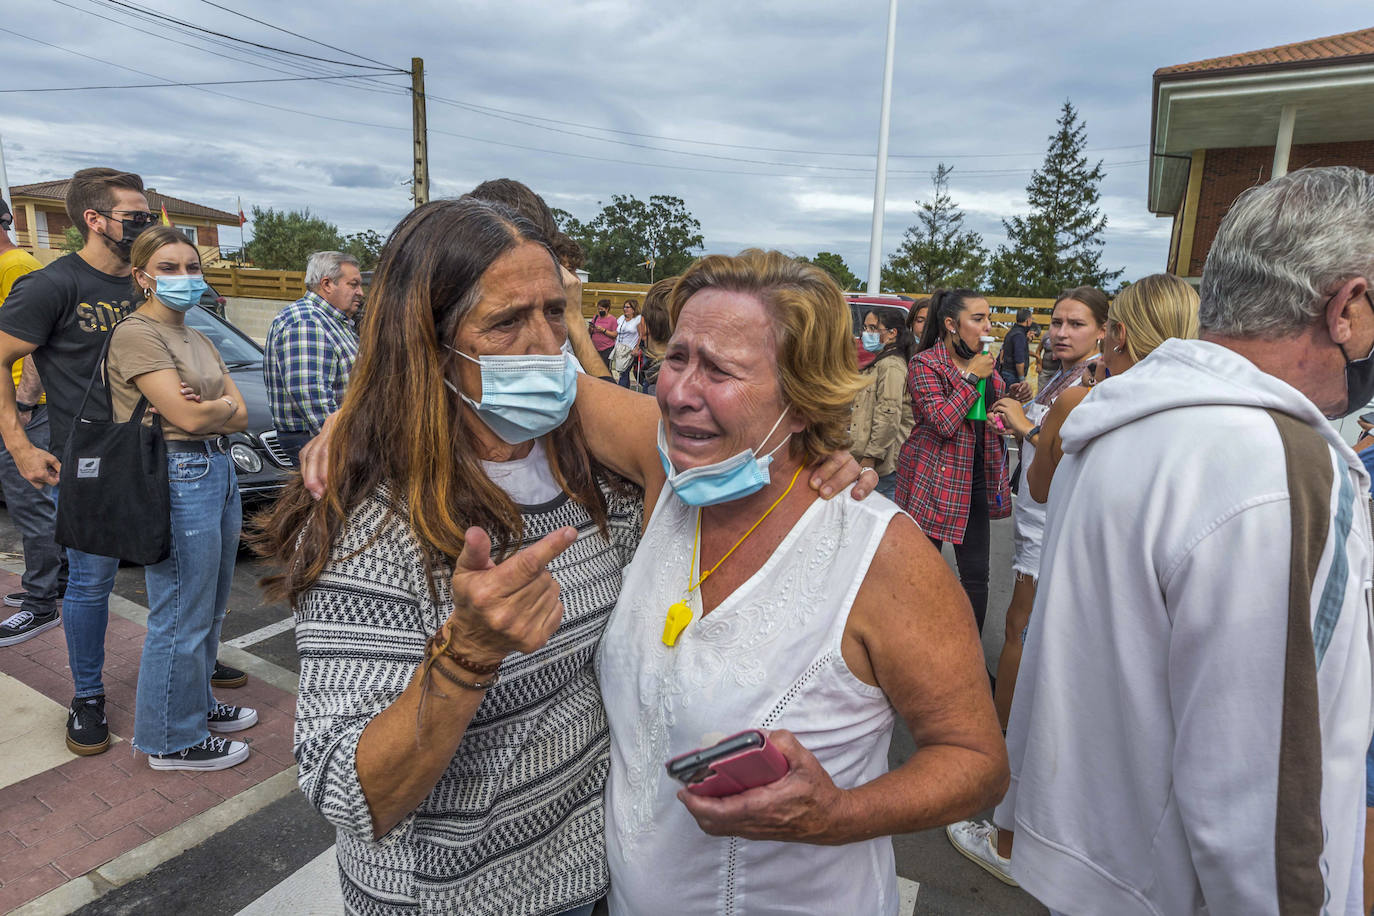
[849,309,916,500]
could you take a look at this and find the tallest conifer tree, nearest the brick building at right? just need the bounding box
[991,100,1124,297]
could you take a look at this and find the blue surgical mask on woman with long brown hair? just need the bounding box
[444,347,577,445]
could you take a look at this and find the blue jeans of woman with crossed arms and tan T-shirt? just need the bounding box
[133,452,243,754]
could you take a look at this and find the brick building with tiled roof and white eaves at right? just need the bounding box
[1149,29,1374,277]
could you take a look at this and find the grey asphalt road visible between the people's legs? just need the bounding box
[0,511,1047,916]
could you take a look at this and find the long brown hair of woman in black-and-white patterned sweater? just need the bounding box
[253,198,618,607]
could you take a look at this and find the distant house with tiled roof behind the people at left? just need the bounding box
[10,179,239,264]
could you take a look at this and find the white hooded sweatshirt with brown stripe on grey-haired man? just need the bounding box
[995,341,1374,916]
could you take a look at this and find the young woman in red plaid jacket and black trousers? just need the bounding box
[896,290,1011,630]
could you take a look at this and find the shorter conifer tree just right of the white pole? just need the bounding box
[882,162,988,293]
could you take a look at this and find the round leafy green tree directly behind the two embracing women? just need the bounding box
[554,194,705,283]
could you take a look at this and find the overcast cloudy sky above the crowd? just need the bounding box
[0,0,1374,287]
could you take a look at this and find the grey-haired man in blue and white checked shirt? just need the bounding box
[262,251,363,461]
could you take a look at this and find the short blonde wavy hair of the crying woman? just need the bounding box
[668,249,867,464]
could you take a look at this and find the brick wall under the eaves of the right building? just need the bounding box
[1187,140,1374,276]
